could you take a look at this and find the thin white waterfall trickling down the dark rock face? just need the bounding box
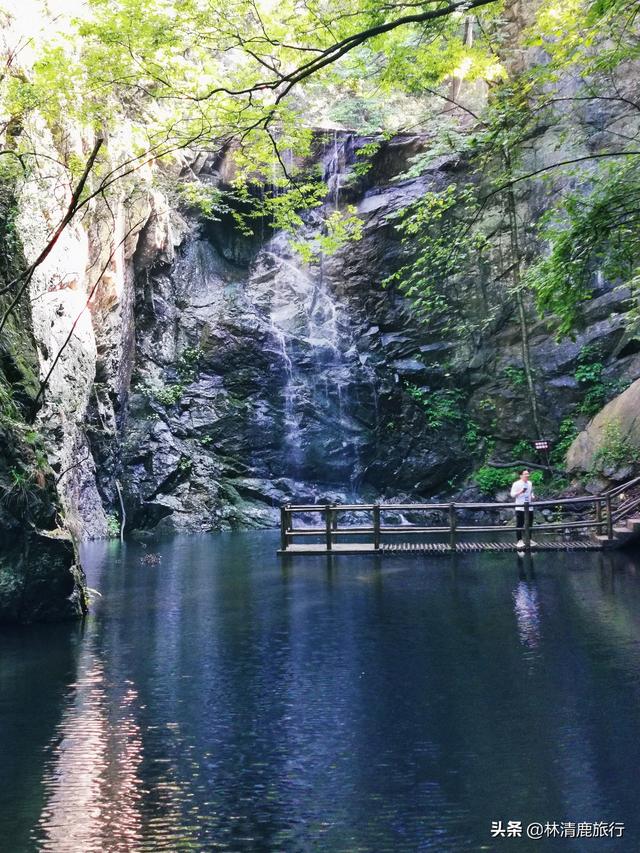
[254,221,362,491]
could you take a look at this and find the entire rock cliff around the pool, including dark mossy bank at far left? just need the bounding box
[0,3,640,621]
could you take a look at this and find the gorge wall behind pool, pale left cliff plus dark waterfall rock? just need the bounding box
[6,125,640,536]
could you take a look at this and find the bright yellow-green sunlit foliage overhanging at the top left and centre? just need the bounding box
[0,0,501,266]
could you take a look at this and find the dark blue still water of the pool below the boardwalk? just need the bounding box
[0,532,640,853]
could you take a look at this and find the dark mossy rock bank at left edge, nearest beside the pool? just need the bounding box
[0,192,86,624]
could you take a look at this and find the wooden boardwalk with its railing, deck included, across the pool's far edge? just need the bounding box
[278,477,640,555]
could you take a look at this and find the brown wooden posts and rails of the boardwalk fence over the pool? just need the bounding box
[280,477,640,552]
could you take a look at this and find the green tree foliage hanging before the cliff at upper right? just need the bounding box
[380,0,640,346]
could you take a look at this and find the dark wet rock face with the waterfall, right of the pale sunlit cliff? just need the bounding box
[118,130,638,530]
